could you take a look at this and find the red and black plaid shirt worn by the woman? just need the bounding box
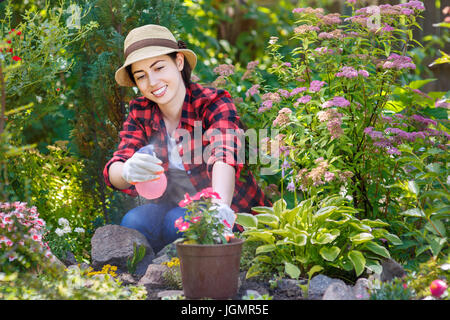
[103,83,271,213]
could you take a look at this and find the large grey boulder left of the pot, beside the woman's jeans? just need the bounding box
[91,225,155,276]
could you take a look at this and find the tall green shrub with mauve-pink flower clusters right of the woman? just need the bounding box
[211,1,449,222]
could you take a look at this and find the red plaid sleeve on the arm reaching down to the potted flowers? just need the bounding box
[203,90,244,178]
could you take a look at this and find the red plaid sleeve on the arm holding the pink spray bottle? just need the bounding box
[103,103,146,196]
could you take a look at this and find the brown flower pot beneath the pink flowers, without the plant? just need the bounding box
[176,238,244,299]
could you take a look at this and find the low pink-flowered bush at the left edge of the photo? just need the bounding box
[0,202,54,273]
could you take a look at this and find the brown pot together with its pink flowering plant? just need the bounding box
[175,188,244,299]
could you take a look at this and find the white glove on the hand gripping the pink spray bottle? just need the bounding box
[122,151,164,184]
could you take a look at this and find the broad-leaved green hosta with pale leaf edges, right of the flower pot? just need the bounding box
[236,196,401,278]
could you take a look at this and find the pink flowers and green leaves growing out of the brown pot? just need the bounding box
[175,188,231,244]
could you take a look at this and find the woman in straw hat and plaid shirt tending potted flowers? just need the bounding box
[103,25,270,252]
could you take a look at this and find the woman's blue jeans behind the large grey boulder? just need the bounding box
[120,203,186,253]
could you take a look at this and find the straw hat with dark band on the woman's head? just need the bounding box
[115,24,197,87]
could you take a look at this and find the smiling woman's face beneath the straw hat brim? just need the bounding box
[131,53,186,107]
